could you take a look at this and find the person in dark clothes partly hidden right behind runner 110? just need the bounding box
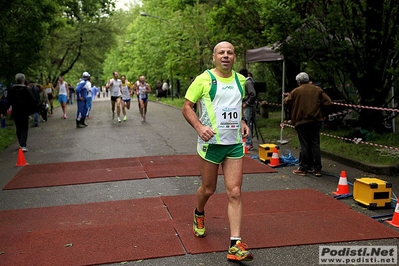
[240,68,256,151]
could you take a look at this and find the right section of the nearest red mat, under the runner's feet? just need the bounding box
[162,189,399,254]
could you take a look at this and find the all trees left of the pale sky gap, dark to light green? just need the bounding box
[0,0,114,86]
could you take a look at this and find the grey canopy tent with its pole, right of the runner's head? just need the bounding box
[246,46,288,144]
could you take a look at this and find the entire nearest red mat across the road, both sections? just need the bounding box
[0,189,399,265]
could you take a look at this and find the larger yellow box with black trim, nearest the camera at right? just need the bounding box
[353,177,392,208]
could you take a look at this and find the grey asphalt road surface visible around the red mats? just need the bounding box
[0,98,399,265]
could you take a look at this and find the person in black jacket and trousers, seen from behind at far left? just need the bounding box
[7,73,37,152]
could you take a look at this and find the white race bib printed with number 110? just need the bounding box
[215,106,241,129]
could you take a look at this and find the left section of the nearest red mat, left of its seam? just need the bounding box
[0,198,184,266]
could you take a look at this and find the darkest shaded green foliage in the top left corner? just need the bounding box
[0,0,58,83]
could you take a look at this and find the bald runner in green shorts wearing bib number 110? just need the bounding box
[182,42,253,261]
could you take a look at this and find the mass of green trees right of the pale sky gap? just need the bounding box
[104,0,399,133]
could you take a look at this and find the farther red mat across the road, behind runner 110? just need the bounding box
[3,155,277,190]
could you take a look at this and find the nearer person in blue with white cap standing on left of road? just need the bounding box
[76,72,91,128]
